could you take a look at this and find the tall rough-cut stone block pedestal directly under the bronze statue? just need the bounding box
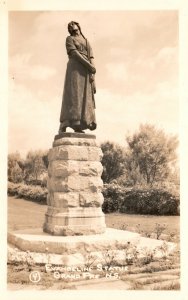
[43,133,106,236]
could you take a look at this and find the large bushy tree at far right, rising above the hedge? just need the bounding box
[126,124,178,186]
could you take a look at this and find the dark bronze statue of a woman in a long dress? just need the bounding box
[59,21,97,134]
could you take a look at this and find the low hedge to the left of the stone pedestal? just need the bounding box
[8,182,48,203]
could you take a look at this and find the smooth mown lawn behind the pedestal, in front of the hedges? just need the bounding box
[8,197,179,237]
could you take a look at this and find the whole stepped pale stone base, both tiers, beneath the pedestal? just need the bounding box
[8,228,176,266]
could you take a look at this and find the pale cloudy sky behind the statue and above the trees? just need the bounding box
[8,10,179,156]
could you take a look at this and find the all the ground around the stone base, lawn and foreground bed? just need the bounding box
[8,197,180,290]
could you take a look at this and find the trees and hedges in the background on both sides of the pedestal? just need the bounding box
[8,124,179,215]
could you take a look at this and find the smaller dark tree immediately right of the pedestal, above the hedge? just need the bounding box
[101,142,125,183]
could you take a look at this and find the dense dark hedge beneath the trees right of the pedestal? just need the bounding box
[103,183,179,215]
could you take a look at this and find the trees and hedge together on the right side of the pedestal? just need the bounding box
[101,124,180,215]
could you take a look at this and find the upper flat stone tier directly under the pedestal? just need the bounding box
[8,228,140,254]
